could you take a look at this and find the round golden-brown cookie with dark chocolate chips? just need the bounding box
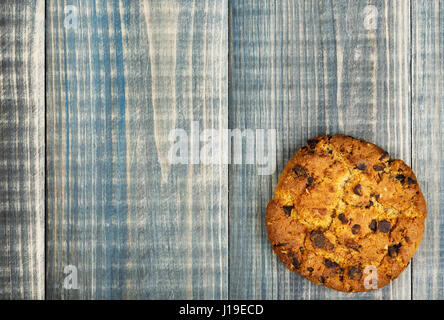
[266,134,426,292]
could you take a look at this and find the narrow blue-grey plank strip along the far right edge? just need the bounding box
[412,0,444,299]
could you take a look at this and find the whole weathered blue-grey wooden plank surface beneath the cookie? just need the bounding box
[0,0,444,299]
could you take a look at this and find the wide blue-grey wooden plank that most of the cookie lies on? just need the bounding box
[229,0,411,299]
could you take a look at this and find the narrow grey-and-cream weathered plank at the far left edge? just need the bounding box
[0,0,45,299]
